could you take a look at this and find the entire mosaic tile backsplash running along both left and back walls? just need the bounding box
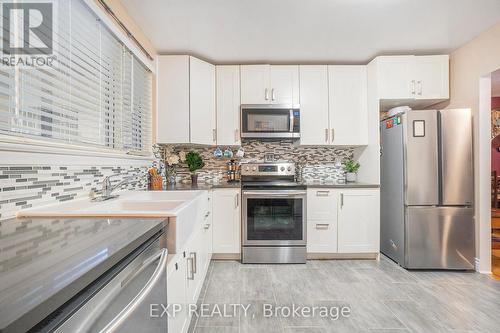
[0,141,354,220]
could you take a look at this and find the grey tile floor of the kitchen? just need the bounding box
[191,257,500,333]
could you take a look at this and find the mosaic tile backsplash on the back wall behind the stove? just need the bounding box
[157,140,354,182]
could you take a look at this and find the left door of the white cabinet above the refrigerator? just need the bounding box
[377,56,416,99]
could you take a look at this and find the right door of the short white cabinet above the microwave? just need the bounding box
[270,65,299,104]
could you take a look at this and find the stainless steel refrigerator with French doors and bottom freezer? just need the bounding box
[380,109,475,269]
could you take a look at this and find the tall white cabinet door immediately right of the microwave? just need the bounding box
[300,65,330,145]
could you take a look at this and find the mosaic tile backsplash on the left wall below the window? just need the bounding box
[0,165,150,220]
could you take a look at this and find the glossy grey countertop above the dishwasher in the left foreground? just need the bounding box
[0,218,165,332]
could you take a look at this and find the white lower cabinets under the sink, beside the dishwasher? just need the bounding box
[167,194,212,333]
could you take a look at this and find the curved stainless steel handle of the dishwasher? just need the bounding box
[100,249,168,333]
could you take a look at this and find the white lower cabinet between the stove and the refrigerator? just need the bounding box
[307,188,380,253]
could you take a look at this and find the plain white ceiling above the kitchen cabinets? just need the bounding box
[121,0,500,63]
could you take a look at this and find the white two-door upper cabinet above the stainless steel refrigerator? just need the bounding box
[375,55,450,101]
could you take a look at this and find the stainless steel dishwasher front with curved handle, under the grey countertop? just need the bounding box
[37,235,168,333]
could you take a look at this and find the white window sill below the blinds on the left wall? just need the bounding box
[0,135,155,165]
